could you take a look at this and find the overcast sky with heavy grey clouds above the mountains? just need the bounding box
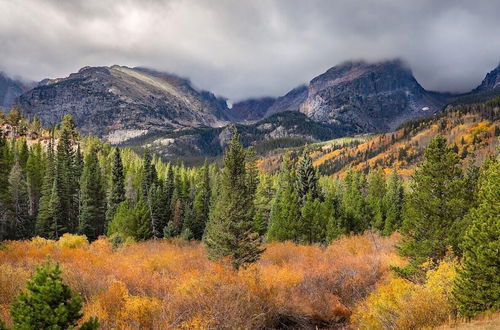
[0,0,500,100]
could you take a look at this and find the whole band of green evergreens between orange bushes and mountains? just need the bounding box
[0,112,500,316]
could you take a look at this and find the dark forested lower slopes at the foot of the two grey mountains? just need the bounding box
[123,112,347,159]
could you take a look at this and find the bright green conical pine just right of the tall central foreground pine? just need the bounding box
[267,155,300,241]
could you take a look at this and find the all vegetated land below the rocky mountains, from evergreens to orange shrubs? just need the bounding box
[0,104,500,329]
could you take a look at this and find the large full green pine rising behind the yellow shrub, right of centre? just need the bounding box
[399,136,466,276]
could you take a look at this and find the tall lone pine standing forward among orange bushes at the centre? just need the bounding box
[204,130,264,270]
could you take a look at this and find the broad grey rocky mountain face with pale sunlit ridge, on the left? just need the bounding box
[18,65,228,136]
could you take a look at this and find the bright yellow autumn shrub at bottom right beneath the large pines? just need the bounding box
[351,259,457,329]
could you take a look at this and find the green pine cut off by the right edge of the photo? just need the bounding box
[453,161,500,318]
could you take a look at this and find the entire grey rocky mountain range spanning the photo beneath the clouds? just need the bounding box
[0,59,500,157]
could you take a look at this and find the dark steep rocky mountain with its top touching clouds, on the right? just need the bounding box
[299,60,447,132]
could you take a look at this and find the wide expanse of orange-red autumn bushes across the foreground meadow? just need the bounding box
[0,233,402,329]
